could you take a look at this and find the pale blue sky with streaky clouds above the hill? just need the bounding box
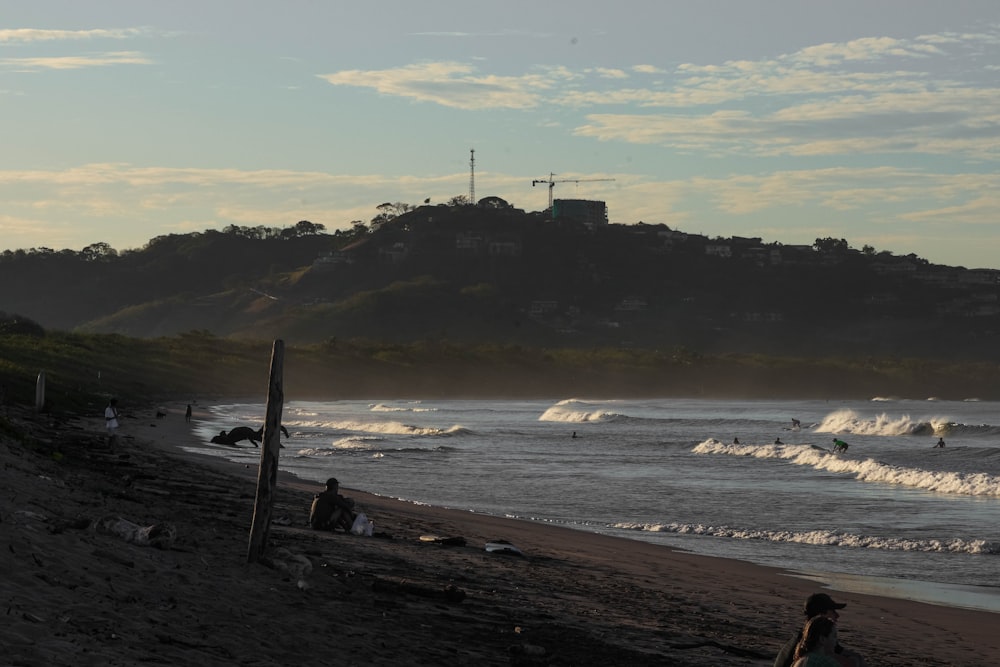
[0,0,1000,269]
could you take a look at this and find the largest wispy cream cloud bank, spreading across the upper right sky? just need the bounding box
[314,28,1000,166]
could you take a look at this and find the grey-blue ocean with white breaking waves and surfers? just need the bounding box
[193,398,1000,612]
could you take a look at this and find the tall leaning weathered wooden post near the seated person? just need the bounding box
[247,340,285,563]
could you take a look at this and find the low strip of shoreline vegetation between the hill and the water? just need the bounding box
[0,332,1000,412]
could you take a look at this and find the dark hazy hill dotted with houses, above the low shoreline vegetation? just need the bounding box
[0,204,1000,360]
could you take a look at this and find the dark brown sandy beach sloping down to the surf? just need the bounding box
[0,405,1000,666]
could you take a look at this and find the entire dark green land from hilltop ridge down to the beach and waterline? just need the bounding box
[0,202,1000,407]
